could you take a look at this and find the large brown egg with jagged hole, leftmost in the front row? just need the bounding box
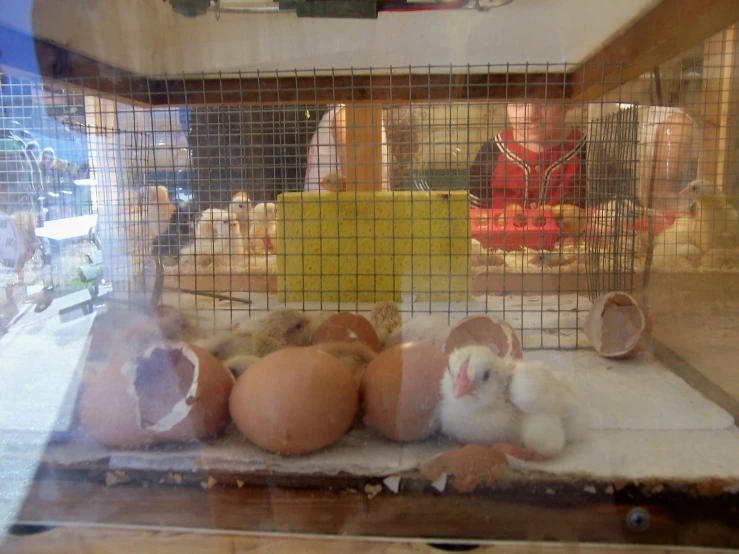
[79,342,234,447]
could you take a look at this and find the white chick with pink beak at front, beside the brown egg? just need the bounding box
[438,345,522,445]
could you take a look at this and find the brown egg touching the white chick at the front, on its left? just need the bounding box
[359,342,449,441]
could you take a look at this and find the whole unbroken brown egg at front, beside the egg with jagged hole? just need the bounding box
[230,347,359,455]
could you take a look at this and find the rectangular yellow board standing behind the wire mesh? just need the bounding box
[276,191,470,302]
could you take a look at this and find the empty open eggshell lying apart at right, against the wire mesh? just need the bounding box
[583,292,651,359]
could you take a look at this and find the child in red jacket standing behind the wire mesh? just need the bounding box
[469,83,586,209]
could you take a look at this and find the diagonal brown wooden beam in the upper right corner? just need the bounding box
[570,0,739,102]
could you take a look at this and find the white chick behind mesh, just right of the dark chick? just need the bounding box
[180,208,244,265]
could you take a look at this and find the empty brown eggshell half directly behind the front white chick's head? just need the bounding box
[444,315,523,360]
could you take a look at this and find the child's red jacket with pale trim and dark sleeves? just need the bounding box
[469,129,586,208]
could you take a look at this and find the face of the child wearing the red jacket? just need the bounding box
[506,102,569,143]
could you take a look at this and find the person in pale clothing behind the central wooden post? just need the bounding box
[303,104,390,192]
